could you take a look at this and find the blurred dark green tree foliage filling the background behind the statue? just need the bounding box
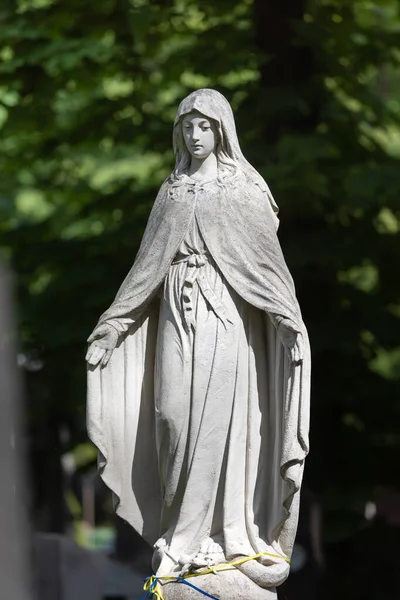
[0,0,400,596]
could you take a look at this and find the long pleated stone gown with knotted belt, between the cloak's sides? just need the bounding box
[154,211,283,574]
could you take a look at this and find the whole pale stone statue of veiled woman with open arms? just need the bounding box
[86,89,310,600]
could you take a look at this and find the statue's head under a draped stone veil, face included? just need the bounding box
[173,89,242,179]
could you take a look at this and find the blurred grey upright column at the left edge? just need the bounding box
[0,264,33,600]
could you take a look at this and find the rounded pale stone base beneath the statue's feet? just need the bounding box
[158,569,278,600]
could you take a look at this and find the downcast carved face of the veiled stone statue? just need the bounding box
[182,111,217,159]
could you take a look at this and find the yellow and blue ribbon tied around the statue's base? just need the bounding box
[141,552,290,600]
